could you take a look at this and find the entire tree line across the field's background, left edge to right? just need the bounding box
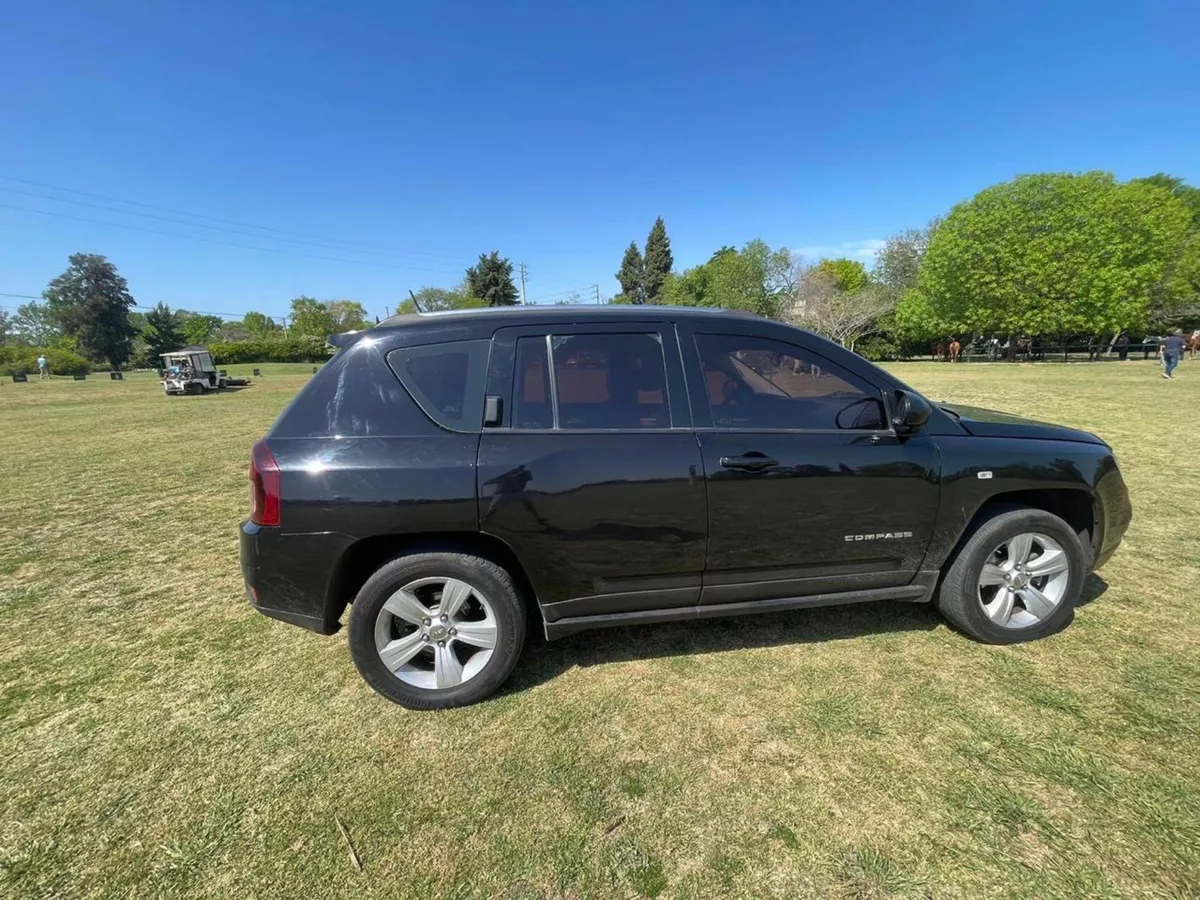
[0,172,1200,367]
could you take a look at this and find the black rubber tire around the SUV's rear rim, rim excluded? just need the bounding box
[349,553,526,709]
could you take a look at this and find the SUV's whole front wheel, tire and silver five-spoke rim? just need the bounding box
[937,508,1087,643]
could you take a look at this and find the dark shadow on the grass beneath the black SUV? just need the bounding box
[500,575,1109,694]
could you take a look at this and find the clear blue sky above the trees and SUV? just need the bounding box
[0,0,1200,324]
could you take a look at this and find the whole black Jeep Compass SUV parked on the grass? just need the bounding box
[241,306,1130,709]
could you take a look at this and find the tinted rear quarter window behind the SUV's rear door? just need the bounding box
[388,340,492,431]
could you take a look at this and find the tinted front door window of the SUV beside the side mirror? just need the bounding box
[696,335,883,428]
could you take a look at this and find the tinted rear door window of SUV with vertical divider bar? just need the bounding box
[512,332,671,431]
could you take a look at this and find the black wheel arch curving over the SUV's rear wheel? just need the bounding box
[325,532,541,628]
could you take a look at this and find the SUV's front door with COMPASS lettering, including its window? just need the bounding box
[680,331,938,604]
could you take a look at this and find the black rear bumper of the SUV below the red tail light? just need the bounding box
[239,520,352,635]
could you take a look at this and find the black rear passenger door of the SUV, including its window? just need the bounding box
[478,323,707,620]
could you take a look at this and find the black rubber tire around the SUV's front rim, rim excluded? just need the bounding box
[937,506,1087,644]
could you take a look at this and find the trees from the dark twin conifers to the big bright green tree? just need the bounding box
[600,172,1200,359]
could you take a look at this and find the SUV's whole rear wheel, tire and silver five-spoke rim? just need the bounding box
[349,553,526,709]
